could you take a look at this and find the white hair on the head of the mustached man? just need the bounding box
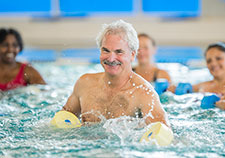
[96,20,139,54]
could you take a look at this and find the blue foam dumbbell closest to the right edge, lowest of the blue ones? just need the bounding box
[201,94,220,109]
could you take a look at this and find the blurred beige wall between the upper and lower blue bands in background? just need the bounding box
[0,0,225,50]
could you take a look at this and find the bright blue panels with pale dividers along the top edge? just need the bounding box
[0,0,202,18]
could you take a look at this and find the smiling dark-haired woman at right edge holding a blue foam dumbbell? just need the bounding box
[193,42,225,109]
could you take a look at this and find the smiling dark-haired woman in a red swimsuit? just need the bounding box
[0,28,46,91]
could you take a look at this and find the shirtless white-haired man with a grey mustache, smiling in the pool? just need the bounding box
[63,20,168,125]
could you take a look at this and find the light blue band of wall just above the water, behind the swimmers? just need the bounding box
[17,46,204,65]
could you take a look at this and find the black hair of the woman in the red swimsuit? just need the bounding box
[0,28,23,52]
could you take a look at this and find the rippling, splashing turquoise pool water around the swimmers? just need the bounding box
[0,63,225,158]
